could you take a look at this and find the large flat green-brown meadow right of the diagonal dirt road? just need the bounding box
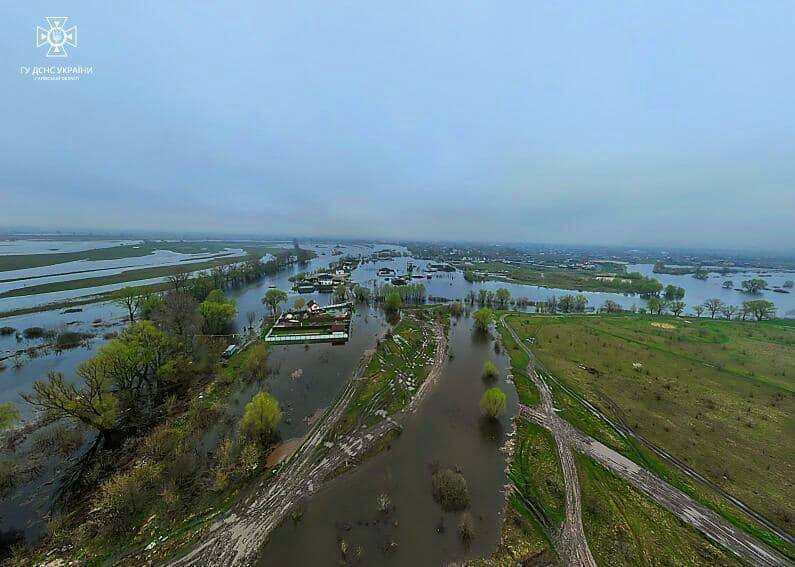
[509,315,795,557]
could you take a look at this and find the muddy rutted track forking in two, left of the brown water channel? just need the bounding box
[171,322,447,567]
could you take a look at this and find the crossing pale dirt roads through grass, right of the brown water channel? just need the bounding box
[500,316,792,567]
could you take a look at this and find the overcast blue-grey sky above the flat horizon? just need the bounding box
[0,0,795,250]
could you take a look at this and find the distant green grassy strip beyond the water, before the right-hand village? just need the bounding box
[464,262,664,293]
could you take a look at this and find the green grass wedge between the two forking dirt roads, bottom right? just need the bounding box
[576,454,742,566]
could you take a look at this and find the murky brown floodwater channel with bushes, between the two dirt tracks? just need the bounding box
[258,318,516,567]
